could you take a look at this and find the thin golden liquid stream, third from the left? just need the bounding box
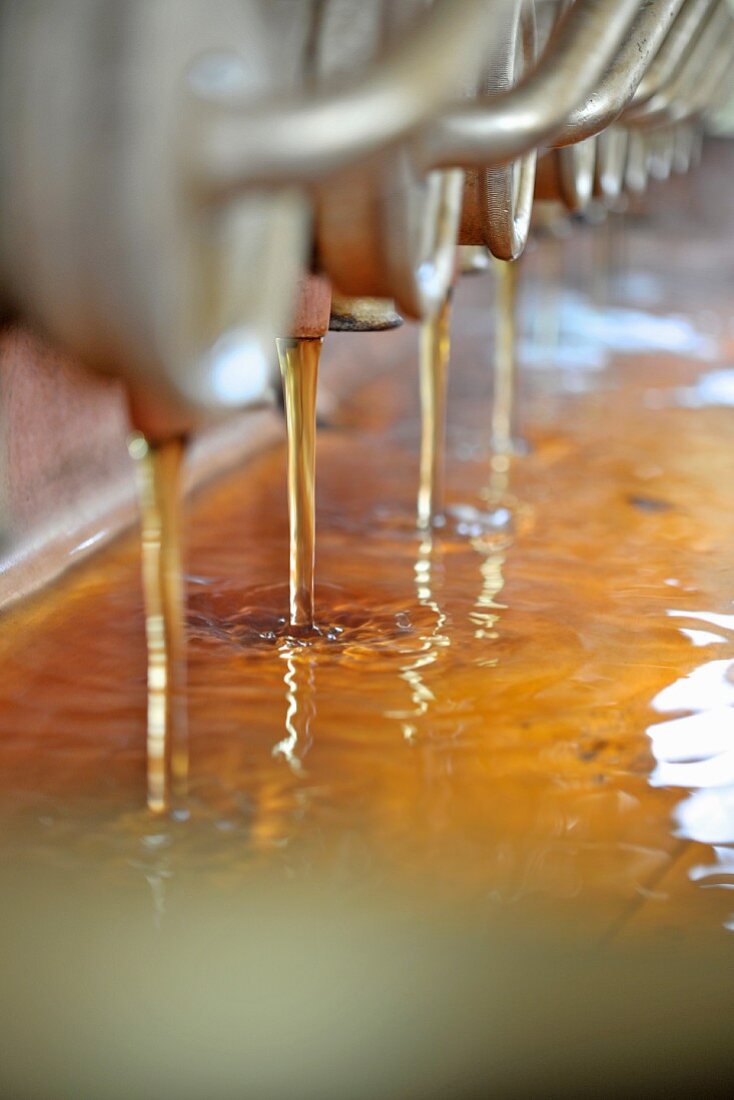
[417,295,451,530]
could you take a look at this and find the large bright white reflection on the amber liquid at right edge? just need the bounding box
[648,611,734,931]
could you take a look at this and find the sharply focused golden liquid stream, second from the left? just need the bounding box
[276,338,324,628]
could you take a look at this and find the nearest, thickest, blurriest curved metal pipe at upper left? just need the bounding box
[184,0,515,194]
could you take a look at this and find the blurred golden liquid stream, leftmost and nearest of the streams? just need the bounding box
[129,433,188,813]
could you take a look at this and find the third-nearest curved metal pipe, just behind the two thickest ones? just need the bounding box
[554,0,686,145]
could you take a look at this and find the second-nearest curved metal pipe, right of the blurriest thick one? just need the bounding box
[417,0,639,168]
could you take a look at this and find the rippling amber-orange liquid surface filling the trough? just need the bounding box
[0,159,734,959]
